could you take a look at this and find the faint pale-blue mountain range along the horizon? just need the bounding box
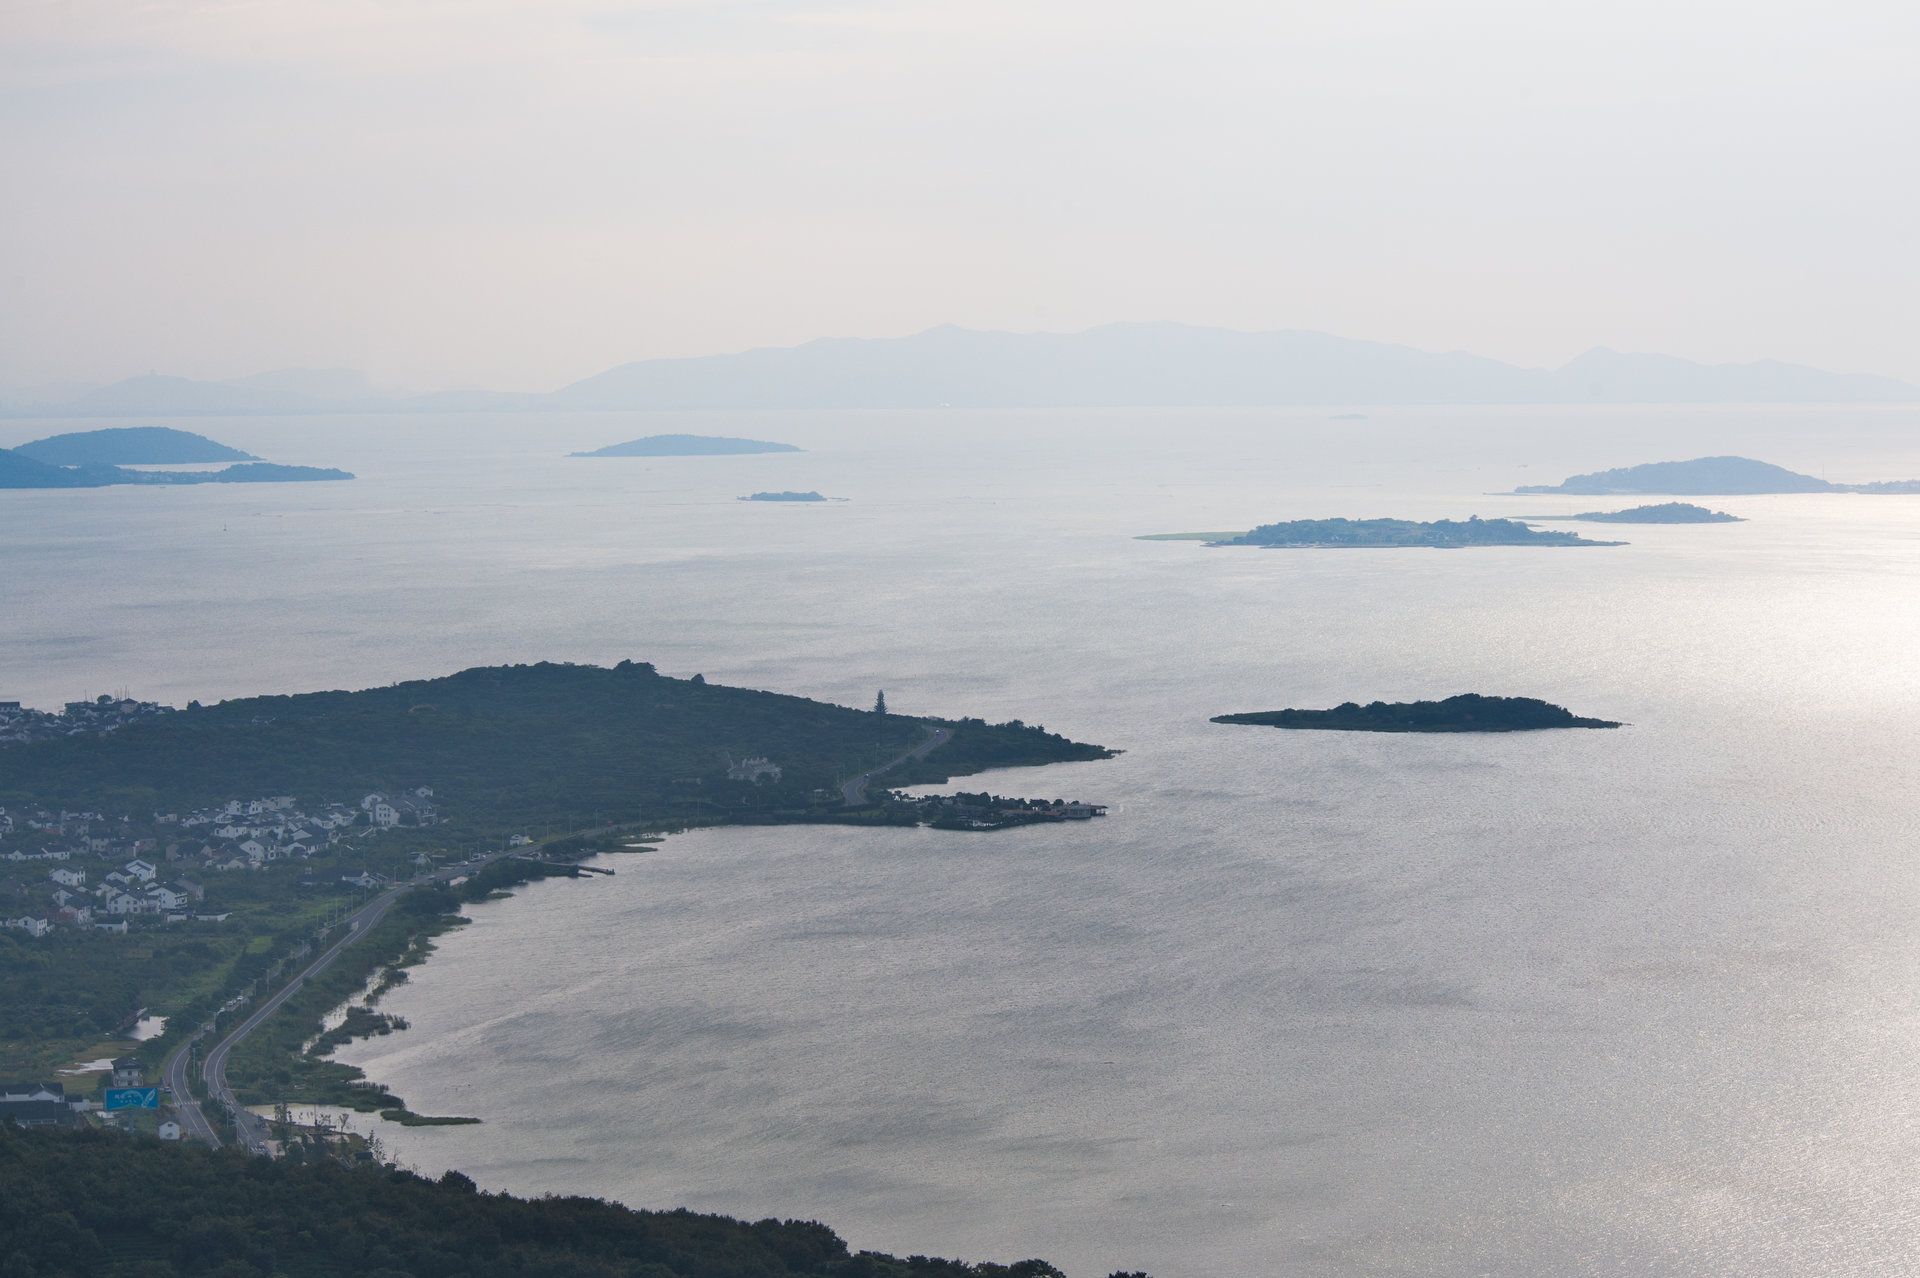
[4,324,1920,416]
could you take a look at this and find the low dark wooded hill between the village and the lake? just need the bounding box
[0,662,1106,842]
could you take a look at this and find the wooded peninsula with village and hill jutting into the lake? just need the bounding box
[0,662,1112,1082]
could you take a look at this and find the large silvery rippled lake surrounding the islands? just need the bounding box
[0,409,1920,1278]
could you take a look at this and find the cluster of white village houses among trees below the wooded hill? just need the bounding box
[0,787,440,936]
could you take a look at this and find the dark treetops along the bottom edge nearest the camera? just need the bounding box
[0,1124,1098,1278]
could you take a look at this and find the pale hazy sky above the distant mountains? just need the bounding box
[0,0,1920,390]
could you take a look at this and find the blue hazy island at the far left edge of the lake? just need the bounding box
[0,426,353,487]
